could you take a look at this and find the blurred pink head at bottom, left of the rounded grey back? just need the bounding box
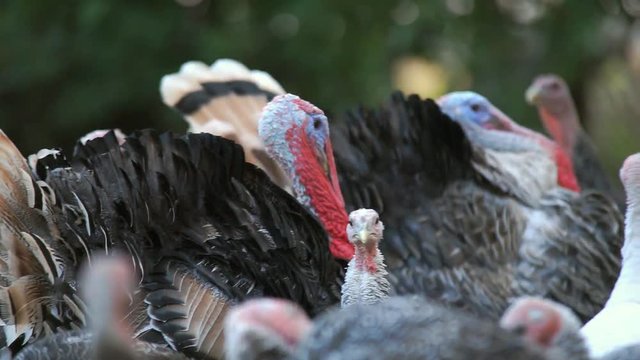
[225,298,311,360]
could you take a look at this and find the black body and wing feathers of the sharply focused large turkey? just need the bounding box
[1,131,343,358]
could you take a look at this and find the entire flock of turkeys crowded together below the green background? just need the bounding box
[0,59,640,360]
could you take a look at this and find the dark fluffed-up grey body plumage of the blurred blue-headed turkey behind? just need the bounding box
[332,94,622,319]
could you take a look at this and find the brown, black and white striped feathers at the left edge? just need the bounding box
[0,132,83,347]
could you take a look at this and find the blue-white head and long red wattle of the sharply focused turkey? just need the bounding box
[258,94,353,260]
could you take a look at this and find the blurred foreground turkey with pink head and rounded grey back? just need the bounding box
[225,296,565,360]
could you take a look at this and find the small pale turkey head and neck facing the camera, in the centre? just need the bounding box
[342,209,391,306]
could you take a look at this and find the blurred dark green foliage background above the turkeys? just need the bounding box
[0,0,640,180]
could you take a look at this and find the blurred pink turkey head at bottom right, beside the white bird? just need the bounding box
[500,297,589,360]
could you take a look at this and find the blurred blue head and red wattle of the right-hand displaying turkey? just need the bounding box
[438,91,580,191]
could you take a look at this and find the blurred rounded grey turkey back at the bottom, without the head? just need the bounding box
[295,297,551,360]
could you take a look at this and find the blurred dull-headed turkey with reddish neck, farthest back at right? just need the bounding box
[526,74,624,207]
